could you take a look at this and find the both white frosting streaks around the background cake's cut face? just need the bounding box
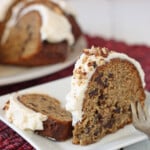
[2,3,74,45]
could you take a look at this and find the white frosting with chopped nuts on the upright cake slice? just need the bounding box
[66,47,145,125]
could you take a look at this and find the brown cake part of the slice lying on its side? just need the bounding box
[4,93,72,141]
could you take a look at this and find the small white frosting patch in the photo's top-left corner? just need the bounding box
[0,0,14,21]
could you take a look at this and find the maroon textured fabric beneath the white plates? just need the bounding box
[0,35,150,150]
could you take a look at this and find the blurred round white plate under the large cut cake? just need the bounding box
[0,38,87,86]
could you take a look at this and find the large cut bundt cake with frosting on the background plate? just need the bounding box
[0,0,82,66]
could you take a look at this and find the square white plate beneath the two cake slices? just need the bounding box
[0,77,150,150]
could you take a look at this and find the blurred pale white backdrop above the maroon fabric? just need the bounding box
[66,0,150,45]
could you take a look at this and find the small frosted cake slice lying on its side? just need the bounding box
[4,93,72,141]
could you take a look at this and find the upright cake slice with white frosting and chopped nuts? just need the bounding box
[66,47,145,145]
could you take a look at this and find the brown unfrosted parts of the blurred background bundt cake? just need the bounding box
[0,0,82,66]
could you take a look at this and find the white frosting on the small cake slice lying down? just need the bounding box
[6,93,47,131]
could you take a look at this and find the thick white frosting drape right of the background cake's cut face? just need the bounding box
[21,4,74,45]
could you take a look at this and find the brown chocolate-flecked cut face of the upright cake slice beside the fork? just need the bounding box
[73,58,145,145]
